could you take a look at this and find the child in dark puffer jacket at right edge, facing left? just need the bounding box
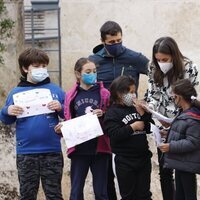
[159,79,200,200]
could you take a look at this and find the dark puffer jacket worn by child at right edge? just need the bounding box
[164,107,200,174]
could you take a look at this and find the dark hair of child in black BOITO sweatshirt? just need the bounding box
[110,76,135,104]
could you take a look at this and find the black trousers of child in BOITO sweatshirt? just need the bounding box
[114,156,152,200]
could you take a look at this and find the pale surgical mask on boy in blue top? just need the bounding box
[31,68,49,83]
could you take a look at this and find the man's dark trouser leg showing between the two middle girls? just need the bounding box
[107,155,117,200]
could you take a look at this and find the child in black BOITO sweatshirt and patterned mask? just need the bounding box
[104,76,152,200]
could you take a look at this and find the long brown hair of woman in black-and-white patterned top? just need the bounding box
[152,37,186,86]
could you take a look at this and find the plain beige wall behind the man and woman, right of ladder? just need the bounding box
[60,0,200,96]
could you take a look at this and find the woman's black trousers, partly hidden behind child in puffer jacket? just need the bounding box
[157,148,175,200]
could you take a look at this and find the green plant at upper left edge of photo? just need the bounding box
[0,0,15,64]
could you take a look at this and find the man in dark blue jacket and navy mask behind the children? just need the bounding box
[89,21,148,200]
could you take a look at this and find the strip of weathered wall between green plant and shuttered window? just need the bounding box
[0,0,24,107]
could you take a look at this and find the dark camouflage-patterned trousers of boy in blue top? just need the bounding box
[17,153,63,200]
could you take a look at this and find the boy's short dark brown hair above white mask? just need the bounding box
[18,48,49,77]
